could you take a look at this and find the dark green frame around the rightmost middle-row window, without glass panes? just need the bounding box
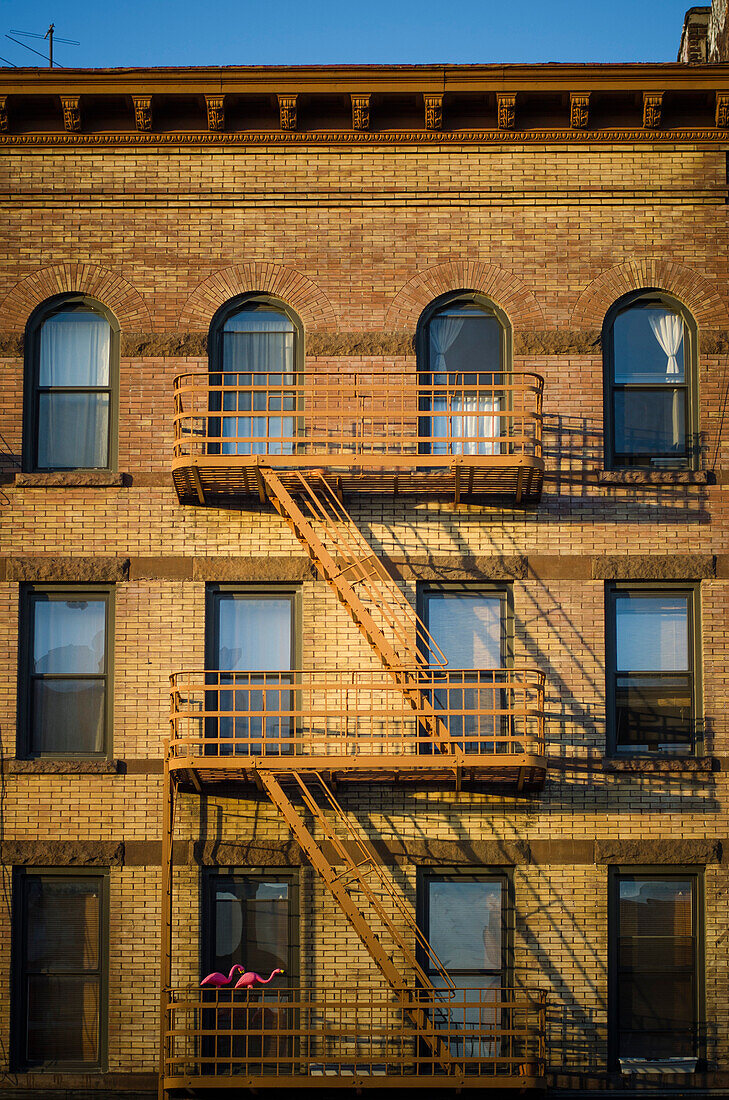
[605,581,705,760]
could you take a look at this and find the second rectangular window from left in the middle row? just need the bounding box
[206,587,299,756]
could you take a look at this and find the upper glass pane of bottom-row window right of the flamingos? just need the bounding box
[428,879,502,971]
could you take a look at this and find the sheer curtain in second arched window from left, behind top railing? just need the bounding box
[221,309,296,454]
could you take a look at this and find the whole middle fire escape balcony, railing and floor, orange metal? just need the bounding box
[168,669,546,791]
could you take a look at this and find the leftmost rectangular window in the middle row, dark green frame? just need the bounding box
[20,587,112,756]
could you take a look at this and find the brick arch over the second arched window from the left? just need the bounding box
[179,263,336,331]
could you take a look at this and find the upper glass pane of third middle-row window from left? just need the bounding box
[427,592,501,669]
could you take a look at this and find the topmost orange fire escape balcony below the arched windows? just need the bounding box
[173,365,544,506]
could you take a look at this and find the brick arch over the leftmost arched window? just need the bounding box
[0,263,152,332]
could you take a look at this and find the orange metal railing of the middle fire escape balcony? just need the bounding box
[169,669,544,761]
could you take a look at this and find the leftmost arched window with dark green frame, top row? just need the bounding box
[23,295,119,471]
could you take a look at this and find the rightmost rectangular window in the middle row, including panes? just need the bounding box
[608,587,697,752]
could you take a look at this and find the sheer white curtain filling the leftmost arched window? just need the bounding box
[36,311,111,470]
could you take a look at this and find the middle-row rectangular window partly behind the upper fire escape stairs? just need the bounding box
[420,585,512,754]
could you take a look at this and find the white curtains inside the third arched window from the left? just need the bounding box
[429,315,501,454]
